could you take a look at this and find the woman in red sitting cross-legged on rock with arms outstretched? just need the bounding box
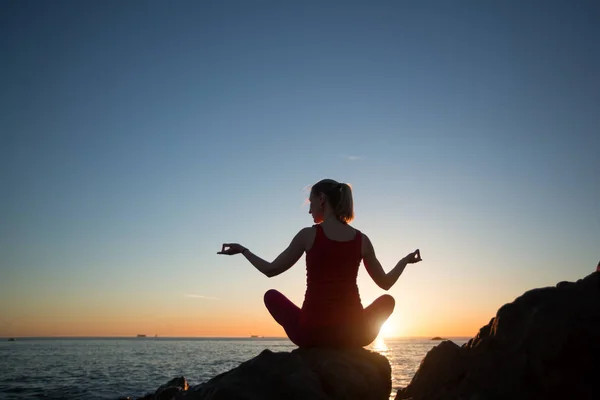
[217,179,421,347]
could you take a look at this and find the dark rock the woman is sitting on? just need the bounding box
[123,348,392,400]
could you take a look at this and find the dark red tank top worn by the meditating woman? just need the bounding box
[300,225,363,326]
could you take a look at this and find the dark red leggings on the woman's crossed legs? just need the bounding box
[264,289,395,348]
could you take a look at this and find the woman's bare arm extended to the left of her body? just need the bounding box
[218,228,310,278]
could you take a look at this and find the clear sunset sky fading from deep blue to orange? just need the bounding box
[0,0,600,336]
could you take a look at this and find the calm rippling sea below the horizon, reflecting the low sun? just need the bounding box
[0,338,467,400]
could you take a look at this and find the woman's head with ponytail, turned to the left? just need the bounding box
[308,179,354,223]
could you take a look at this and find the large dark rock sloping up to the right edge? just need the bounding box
[396,272,600,400]
